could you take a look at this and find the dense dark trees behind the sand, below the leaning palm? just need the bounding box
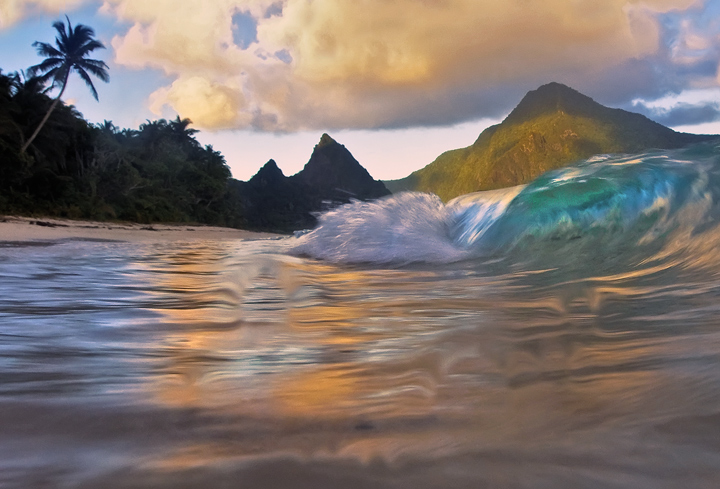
[0,72,235,225]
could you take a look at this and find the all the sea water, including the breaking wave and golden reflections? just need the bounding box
[0,145,720,489]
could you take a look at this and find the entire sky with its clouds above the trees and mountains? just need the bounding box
[0,0,720,180]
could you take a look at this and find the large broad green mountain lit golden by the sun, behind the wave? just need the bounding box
[384,83,717,201]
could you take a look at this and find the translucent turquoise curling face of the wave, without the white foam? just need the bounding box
[477,152,712,254]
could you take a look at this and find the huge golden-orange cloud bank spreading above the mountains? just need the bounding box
[103,0,720,131]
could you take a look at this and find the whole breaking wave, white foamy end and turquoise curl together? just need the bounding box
[292,145,720,263]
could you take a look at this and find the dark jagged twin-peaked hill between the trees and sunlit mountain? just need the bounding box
[230,134,390,232]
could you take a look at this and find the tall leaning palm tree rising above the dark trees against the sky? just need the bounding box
[21,16,110,153]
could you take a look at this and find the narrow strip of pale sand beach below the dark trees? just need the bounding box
[0,216,283,241]
